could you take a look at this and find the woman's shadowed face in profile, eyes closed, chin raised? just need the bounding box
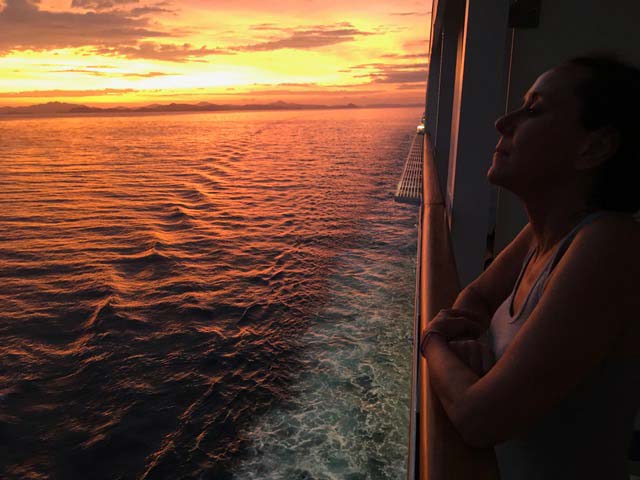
[487,67,587,194]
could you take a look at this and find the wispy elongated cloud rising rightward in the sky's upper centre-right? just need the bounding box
[232,23,375,52]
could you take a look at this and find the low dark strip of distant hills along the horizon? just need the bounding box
[0,101,417,115]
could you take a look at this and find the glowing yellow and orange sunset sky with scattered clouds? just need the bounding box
[0,0,431,106]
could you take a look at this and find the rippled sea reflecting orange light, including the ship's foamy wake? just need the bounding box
[0,108,422,480]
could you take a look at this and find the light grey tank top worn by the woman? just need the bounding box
[488,211,640,480]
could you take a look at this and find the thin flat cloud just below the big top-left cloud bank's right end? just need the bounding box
[93,42,233,62]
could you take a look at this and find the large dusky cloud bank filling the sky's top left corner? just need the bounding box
[0,0,171,55]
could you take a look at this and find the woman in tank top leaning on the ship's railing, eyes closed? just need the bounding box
[421,57,640,480]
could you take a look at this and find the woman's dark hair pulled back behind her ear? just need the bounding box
[564,54,640,213]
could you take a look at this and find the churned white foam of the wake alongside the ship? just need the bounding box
[234,238,414,480]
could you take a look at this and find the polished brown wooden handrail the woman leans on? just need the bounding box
[408,135,499,480]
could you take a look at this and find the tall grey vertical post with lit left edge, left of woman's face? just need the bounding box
[446,0,509,287]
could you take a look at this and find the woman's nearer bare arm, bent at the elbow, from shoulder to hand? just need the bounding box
[426,218,640,447]
